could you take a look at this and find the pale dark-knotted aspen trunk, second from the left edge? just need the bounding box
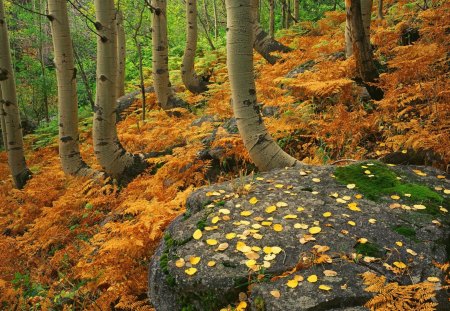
[48,0,94,176]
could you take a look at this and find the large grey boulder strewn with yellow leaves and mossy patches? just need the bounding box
[149,162,450,311]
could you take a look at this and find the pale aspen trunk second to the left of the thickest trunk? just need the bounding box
[151,0,183,110]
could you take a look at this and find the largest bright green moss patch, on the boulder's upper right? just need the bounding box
[334,162,449,215]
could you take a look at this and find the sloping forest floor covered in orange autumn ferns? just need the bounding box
[0,2,450,310]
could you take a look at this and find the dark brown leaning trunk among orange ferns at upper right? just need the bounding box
[346,0,383,100]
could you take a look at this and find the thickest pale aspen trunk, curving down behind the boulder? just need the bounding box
[226,0,298,170]
